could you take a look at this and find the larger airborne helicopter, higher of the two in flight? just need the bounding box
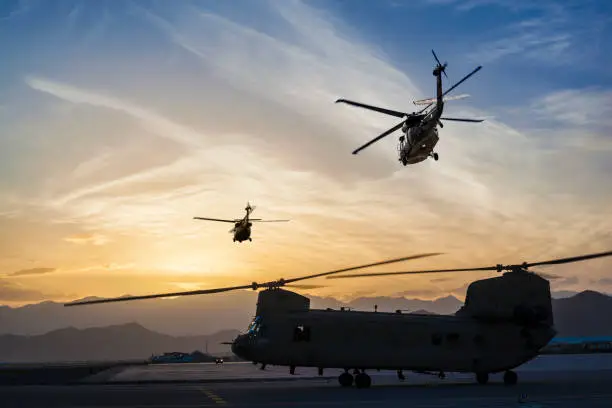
[336,50,483,166]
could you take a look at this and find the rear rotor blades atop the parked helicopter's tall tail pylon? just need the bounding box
[327,251,612,279]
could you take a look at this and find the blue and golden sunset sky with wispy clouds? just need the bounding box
[0,0,612,305]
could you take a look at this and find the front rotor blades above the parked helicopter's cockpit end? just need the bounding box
[64,253,441,307]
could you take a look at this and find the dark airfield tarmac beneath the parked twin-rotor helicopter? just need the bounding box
[0,354,612,408]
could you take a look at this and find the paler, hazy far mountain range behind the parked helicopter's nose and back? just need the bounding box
[0,291,462,336]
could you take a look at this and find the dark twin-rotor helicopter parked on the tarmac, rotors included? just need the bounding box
[64,251,612,388]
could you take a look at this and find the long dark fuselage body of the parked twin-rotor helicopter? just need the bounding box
[232,304,555,373]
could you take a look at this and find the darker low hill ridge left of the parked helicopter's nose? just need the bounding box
[0,323,238,362]
